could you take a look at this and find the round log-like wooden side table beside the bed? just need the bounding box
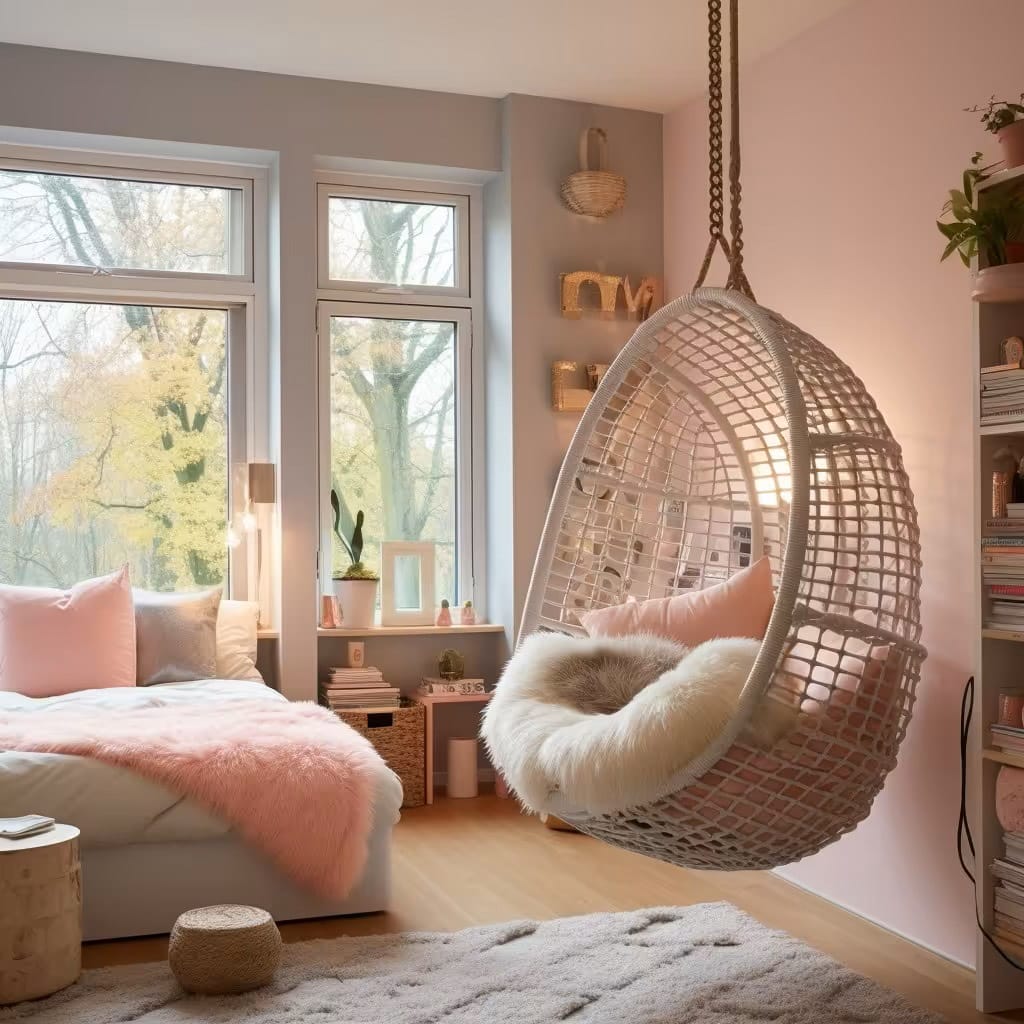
[0,825,82,1004]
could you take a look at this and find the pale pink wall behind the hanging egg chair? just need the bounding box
[665,0,1024,963]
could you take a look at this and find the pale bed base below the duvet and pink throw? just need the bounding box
[81,821,393,941]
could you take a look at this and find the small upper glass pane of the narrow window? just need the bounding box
[328,196,458,288]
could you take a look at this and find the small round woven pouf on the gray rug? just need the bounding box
[167,904,281,995]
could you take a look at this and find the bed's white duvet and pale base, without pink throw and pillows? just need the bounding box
[0,680,402,940]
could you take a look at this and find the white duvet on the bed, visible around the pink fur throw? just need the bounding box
[0,679,401,846]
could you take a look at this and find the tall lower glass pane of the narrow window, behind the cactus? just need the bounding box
[331,316,459,602]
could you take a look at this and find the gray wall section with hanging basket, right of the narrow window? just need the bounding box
[484,95,663,627]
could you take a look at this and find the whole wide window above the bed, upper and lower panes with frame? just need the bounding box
[0,151,255,592]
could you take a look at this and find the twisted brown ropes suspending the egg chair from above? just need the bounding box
[693,0,757,302]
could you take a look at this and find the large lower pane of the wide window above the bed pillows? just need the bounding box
[0,299,227,590]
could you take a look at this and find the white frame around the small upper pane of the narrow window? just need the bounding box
[316,181,472,305]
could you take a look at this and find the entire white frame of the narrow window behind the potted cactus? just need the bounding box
[315,170,486,622]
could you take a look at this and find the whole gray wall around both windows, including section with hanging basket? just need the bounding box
[0,44,662,698]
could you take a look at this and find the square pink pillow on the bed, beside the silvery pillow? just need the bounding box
[0,565,135,697]
